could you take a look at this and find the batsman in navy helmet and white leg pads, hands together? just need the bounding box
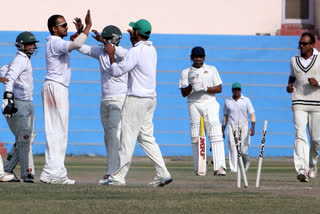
[179,47,226,176]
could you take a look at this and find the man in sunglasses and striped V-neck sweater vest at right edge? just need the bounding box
[287,32,320,182]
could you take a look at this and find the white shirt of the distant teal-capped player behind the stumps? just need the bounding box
[223,95,254,127]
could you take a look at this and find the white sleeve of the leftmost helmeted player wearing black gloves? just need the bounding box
[5,55,28,92]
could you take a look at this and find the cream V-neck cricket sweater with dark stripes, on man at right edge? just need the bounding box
[290,49,320,112]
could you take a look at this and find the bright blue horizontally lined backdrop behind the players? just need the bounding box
[0,31,299,156]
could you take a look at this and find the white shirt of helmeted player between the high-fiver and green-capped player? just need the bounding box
[79,45,128,99]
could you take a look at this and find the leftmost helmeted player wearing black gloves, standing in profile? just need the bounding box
[1,31,38,183]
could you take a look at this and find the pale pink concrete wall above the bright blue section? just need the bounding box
[0,0,282,35]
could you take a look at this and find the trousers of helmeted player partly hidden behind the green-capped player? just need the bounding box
[100,96,126,175]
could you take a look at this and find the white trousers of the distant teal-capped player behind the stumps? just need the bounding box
[227,124,250,172]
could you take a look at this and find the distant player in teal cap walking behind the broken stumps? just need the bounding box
[222,82,256,172]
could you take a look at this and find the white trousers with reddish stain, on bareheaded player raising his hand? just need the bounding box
[40,81,69,179]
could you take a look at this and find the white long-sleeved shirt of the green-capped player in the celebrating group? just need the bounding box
[111,41,157,98]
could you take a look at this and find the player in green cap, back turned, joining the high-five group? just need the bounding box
[104,19,172,187]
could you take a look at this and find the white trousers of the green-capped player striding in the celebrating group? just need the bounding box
[110,96,170,183]
